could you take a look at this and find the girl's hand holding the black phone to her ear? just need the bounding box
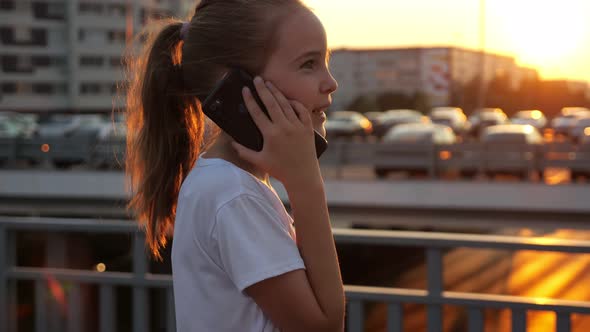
[232,77,319,187]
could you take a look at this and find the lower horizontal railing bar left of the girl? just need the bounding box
[6,267,172,288]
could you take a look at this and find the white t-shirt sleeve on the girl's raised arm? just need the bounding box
[212,195,305,291]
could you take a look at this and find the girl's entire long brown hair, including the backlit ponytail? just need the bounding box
[125,0,308,259]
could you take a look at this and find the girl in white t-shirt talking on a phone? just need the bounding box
[127,0,345,332]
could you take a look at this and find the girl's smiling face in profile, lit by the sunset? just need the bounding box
[260,10,338,136]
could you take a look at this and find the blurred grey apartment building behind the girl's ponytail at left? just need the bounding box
[0,0,180,113]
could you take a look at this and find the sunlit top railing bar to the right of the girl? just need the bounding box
[332,228,590,253]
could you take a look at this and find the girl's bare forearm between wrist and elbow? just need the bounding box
[285,168,345,329]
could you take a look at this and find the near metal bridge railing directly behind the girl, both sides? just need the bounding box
[0,217,590,332]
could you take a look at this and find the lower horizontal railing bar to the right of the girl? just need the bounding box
[344,285,590,314]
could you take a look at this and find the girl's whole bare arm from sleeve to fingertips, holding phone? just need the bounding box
[234,79,345,331]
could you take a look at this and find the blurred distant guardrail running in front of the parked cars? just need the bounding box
[0,138,590,180]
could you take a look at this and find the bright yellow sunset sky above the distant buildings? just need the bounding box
[304,0,590,82]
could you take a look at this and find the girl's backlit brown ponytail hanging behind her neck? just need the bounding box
[125,21,204,259]
